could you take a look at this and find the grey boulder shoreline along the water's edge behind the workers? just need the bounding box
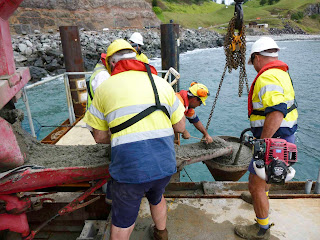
[12,28,320,82]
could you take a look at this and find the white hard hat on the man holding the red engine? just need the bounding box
[248,37,280,65]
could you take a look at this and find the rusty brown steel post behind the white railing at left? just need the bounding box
[59,26,87,117]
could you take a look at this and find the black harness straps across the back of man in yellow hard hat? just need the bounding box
[110,63,170,134]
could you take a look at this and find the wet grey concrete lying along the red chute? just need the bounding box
[0,109,245,172]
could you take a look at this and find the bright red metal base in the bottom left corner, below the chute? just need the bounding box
[0,195,31,237]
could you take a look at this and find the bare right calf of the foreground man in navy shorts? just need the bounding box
[150,195,167,230]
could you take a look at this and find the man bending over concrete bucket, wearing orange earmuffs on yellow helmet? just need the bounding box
[176,82,213,143]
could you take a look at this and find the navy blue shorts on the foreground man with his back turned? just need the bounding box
[108,176,171,228]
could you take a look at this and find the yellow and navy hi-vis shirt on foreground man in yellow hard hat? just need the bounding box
[84,60,183,183]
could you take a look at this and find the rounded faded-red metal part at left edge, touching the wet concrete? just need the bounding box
[0,117,24,169]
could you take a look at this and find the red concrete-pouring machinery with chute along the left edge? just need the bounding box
[0,0,109,239]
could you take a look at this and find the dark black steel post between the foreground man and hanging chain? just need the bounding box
[160,23,180,91]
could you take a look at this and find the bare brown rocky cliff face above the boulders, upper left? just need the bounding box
[10,0,160,34]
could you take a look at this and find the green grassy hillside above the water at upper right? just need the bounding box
[153,0,320,34]
